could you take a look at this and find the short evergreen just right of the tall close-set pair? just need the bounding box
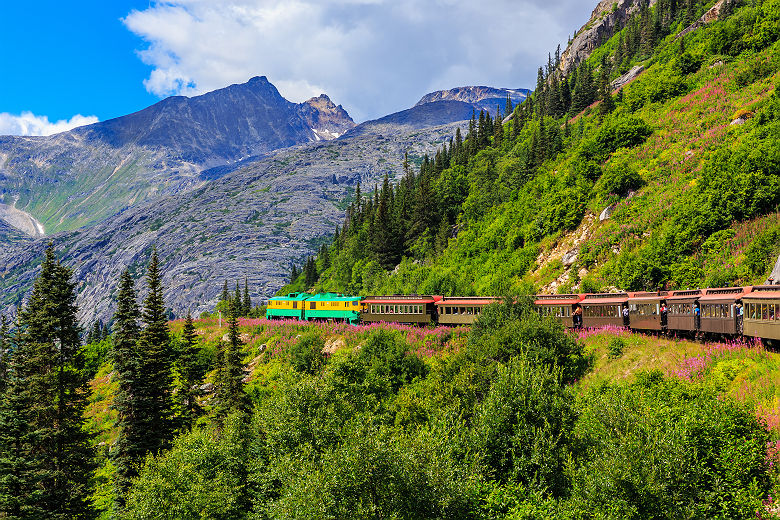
[176,313,203,431]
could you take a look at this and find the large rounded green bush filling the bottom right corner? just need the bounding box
[572,378,772,519]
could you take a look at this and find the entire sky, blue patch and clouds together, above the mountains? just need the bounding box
[0,0,596,134]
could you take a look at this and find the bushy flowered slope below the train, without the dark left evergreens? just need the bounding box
[76,306,780,519]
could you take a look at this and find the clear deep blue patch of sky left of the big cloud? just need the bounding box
[0,0,159,121]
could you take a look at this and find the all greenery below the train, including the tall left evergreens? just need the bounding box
[0,248,780,520]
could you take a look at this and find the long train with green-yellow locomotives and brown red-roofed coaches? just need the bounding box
[266,285,780,341]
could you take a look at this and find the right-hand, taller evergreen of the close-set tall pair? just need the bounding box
[136,249,174,454]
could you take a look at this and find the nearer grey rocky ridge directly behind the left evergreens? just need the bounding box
[0,123,462,323]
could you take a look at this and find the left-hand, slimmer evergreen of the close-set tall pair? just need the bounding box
[111,269,146,511]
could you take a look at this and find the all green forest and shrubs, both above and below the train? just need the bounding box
[0,0,780,520]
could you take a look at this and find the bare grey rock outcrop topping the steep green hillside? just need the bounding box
[560,0,657,74]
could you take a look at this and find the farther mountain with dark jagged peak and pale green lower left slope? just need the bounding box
[0,77,355,234]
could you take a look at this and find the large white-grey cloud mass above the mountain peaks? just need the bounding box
[124,0,593,120]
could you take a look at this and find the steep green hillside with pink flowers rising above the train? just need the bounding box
[296,0,780,295]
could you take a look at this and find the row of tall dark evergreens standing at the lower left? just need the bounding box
[0,245,249,519]
